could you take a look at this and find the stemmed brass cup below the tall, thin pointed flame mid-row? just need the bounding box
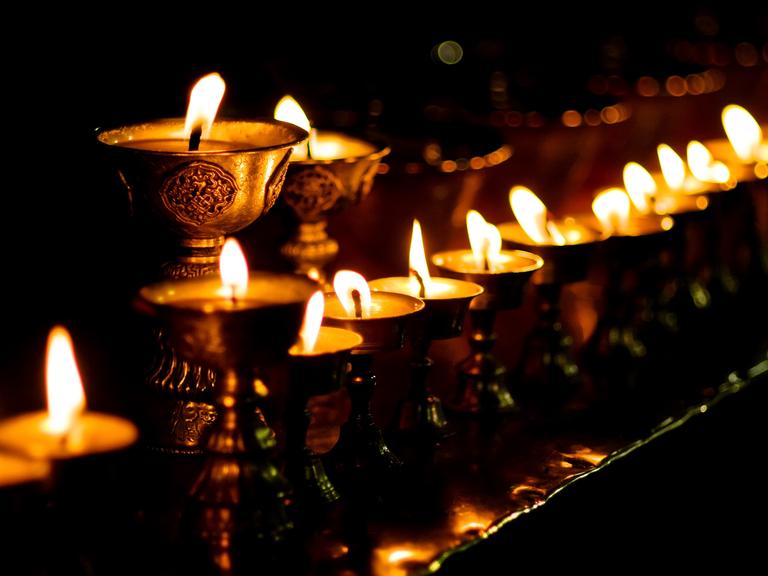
[368,277,483,444]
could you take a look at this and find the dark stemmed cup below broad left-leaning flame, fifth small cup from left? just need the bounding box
[499,222,603,410]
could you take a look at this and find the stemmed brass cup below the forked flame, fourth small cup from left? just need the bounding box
[432,250,544,414]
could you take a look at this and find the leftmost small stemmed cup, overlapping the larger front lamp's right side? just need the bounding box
[285,326,363,510]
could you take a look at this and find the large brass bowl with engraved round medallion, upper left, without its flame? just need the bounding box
[98,118,308,248]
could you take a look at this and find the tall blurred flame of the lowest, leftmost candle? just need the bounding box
[45,326,85,434]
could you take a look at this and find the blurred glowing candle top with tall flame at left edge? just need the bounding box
[0,326,138,460]
